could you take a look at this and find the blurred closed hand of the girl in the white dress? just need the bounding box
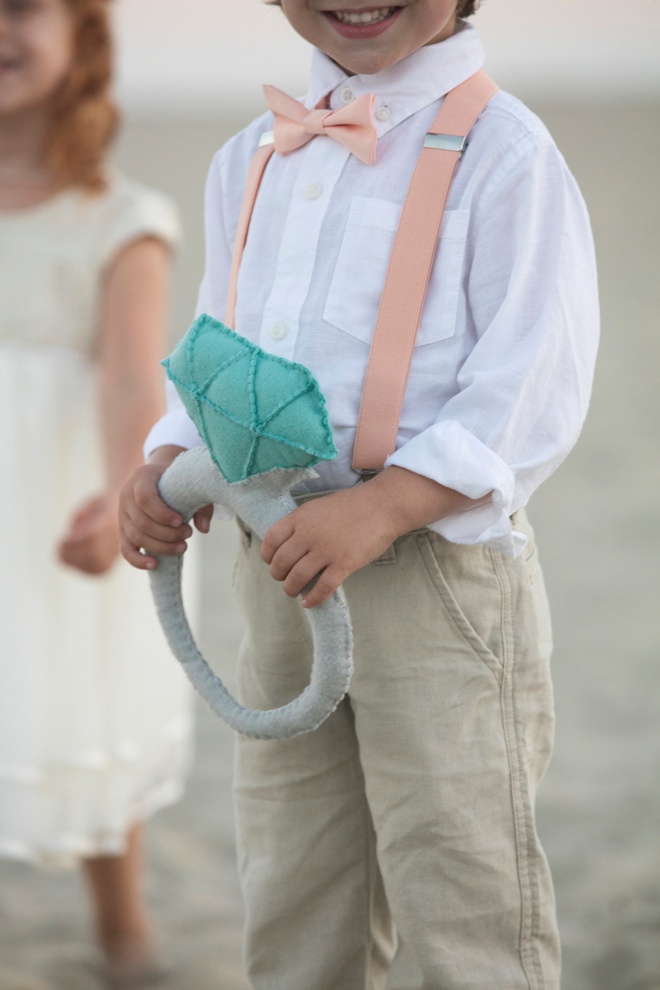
[57,495,119,574]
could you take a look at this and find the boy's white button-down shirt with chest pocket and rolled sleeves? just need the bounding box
[147,25,598,555]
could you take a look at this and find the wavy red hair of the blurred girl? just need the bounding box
[48,0,118,192]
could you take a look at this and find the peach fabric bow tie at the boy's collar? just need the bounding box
[264,86,377,165]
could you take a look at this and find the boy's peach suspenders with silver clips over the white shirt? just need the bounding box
[225,72,498,474]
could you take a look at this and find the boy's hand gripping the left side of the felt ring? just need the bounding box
[119,448,213,571]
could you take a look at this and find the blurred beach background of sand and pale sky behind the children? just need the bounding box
[0,0,660,990]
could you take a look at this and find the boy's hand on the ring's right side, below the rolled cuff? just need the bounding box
[261,483,399,608]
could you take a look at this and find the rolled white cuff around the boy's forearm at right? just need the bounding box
[385,420,527,557]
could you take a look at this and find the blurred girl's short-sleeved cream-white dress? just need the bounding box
[0,175,192,865]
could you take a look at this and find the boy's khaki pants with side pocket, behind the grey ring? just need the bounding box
[235,513,559,990]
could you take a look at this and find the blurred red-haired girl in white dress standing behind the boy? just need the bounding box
[0,0,191,986]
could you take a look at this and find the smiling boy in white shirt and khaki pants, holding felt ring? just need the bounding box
[121,0,598,990]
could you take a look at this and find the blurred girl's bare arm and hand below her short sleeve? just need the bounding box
[58,237,171,574]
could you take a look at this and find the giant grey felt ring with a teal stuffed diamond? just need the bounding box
[149,314,353,739]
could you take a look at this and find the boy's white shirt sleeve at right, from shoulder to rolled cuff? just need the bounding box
[387,137,599,556]
